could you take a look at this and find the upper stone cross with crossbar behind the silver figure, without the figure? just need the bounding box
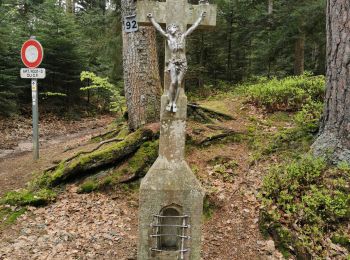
[136,0,216,112]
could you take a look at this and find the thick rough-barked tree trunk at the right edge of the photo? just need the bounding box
[313,0,350,163]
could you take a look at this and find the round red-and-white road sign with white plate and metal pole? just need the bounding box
[21,36,46,160]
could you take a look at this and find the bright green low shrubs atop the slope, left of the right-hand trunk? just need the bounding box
[246,74,325,112]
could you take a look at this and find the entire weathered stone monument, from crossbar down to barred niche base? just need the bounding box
[136,0,216,260]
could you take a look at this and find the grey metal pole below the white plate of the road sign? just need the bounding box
[32,79,39,160]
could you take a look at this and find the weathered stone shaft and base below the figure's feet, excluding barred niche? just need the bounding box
[138,92,204,260]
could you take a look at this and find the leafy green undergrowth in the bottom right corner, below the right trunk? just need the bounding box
[260,156,350,259]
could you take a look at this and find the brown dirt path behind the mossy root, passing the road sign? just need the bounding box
[0,116,113,196]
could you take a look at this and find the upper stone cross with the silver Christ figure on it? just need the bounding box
[136,0,216,113]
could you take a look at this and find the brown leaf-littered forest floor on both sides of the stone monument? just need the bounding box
[0,97,283,260]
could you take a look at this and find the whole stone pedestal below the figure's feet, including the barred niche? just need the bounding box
[138,92,204,260]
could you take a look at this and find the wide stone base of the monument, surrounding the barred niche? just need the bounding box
[138,156,204,260]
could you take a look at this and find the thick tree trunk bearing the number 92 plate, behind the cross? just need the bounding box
[121,0,161,130]
